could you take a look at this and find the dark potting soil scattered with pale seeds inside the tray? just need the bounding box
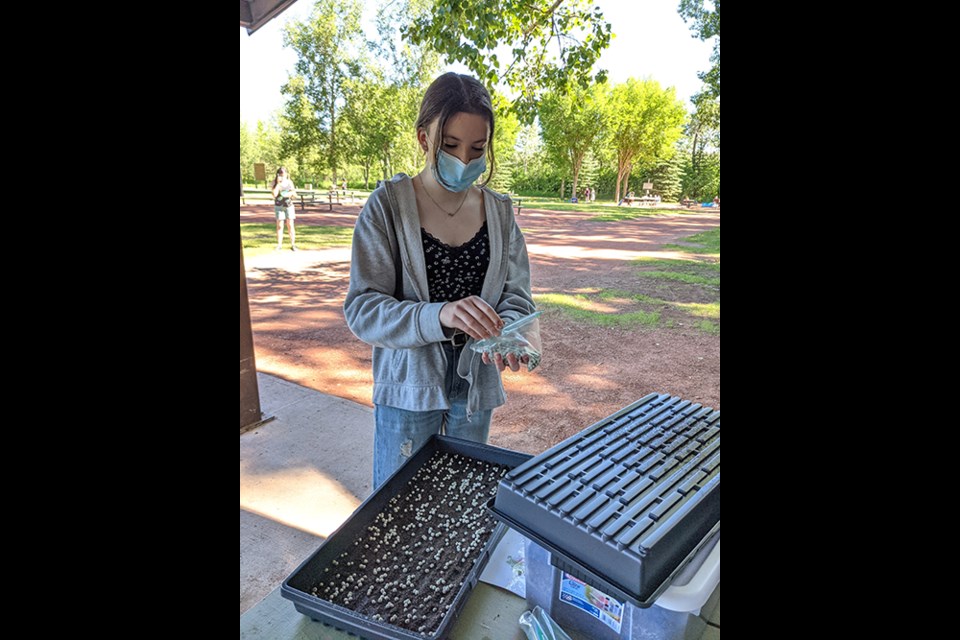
[311,452,508,636]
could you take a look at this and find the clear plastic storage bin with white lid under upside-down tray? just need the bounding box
[525,532,720,640]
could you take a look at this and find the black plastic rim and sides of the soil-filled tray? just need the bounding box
[280,435,532,640]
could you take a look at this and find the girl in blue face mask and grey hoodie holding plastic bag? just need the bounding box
[343,73,540,489]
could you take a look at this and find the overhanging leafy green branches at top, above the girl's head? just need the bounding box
[404,0,610,124]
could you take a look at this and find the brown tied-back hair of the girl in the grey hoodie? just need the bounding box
[416,71,496,186]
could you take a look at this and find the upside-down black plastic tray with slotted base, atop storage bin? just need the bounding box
[490,393,720,607]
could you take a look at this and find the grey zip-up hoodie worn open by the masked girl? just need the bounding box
[343,173,536,416]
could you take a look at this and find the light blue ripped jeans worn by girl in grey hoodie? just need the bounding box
[373,343,493,491]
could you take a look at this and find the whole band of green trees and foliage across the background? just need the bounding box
[240,0,719,199]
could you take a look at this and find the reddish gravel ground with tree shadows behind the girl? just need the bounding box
[240,205,720,453]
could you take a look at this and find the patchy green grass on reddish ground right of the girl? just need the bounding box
[534,228,720,335]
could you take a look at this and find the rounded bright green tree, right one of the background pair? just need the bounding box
[606,78,686,201]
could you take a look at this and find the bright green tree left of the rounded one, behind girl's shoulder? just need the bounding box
[540,85,604,197]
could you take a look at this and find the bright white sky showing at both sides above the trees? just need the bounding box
[240,0,713,124]
